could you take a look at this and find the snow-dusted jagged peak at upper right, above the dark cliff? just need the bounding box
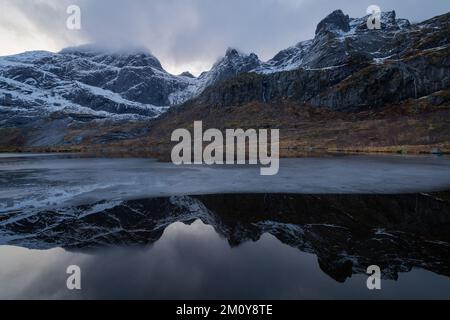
[255,10,410,73]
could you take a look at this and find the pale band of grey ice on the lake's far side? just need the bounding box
[0,154,450,213]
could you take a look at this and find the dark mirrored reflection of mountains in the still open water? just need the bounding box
[0,193,450,298]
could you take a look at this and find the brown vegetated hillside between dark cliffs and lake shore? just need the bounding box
[70,91,450,160]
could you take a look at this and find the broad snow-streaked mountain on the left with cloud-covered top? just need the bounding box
[0,46,189,125]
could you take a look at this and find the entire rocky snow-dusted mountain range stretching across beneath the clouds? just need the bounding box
[0,10,450,150]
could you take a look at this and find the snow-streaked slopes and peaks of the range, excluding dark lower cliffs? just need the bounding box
[0,10,409,126]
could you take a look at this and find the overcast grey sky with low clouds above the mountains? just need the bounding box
[0,0,450,74]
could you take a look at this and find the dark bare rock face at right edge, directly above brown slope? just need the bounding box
[311,47,450,111]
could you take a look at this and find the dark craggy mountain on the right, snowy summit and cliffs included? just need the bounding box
[196,10,450,112]
